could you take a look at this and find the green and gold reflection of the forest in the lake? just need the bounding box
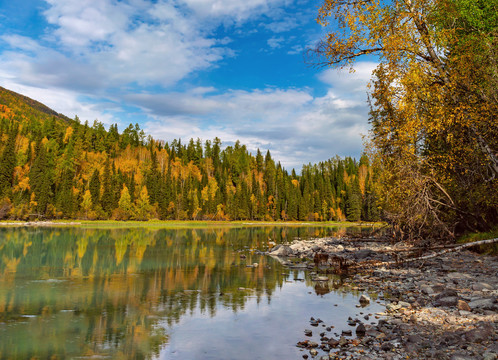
[0,227,374,359]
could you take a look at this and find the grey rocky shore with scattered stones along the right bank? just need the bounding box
[269,238,498,360]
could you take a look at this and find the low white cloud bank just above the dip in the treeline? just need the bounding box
[136,63,375,169]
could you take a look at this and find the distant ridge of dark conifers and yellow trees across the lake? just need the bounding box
[0,88,380,221]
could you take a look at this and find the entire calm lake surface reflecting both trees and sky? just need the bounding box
[0,227,377,359]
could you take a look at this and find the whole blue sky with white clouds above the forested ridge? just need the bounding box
[0,0,375,170]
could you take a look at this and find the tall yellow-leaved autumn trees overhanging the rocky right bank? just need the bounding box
[309,0,498,239]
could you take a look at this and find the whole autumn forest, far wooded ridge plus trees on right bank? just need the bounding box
[0,0,498,245]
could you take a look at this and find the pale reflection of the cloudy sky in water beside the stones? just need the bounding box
[160,274,380,359]
